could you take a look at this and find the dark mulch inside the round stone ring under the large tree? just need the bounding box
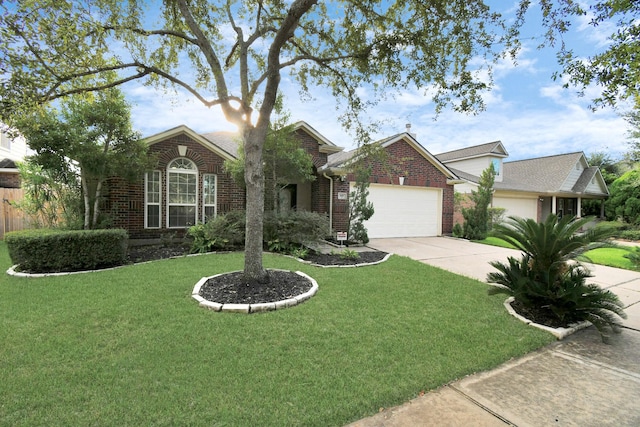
[200,270,313,304]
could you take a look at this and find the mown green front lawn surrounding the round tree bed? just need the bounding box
[0,242,554,426]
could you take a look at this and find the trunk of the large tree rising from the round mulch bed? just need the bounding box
[243,127,268,282]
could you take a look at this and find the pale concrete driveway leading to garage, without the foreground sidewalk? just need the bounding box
[368,237,640,331]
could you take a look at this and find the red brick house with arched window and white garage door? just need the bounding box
[105,122,458,239]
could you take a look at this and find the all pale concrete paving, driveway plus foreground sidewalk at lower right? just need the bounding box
[350,238,640,427]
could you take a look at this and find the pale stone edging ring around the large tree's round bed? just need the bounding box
[191,268,318,314]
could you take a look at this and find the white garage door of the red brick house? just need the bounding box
[364,184,442,239]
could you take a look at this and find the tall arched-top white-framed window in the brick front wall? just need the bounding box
[167,158,198,228]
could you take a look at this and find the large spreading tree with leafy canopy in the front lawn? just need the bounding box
[0,0,636,279]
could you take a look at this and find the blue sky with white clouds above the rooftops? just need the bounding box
[123,0,628,160]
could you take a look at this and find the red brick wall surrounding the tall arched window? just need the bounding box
[107,135,245,239]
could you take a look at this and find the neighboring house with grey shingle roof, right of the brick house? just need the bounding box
[436,141,609,221]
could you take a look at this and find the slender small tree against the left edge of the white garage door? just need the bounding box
[347,167,375,243]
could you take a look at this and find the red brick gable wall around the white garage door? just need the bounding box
[333,140,454,234]
